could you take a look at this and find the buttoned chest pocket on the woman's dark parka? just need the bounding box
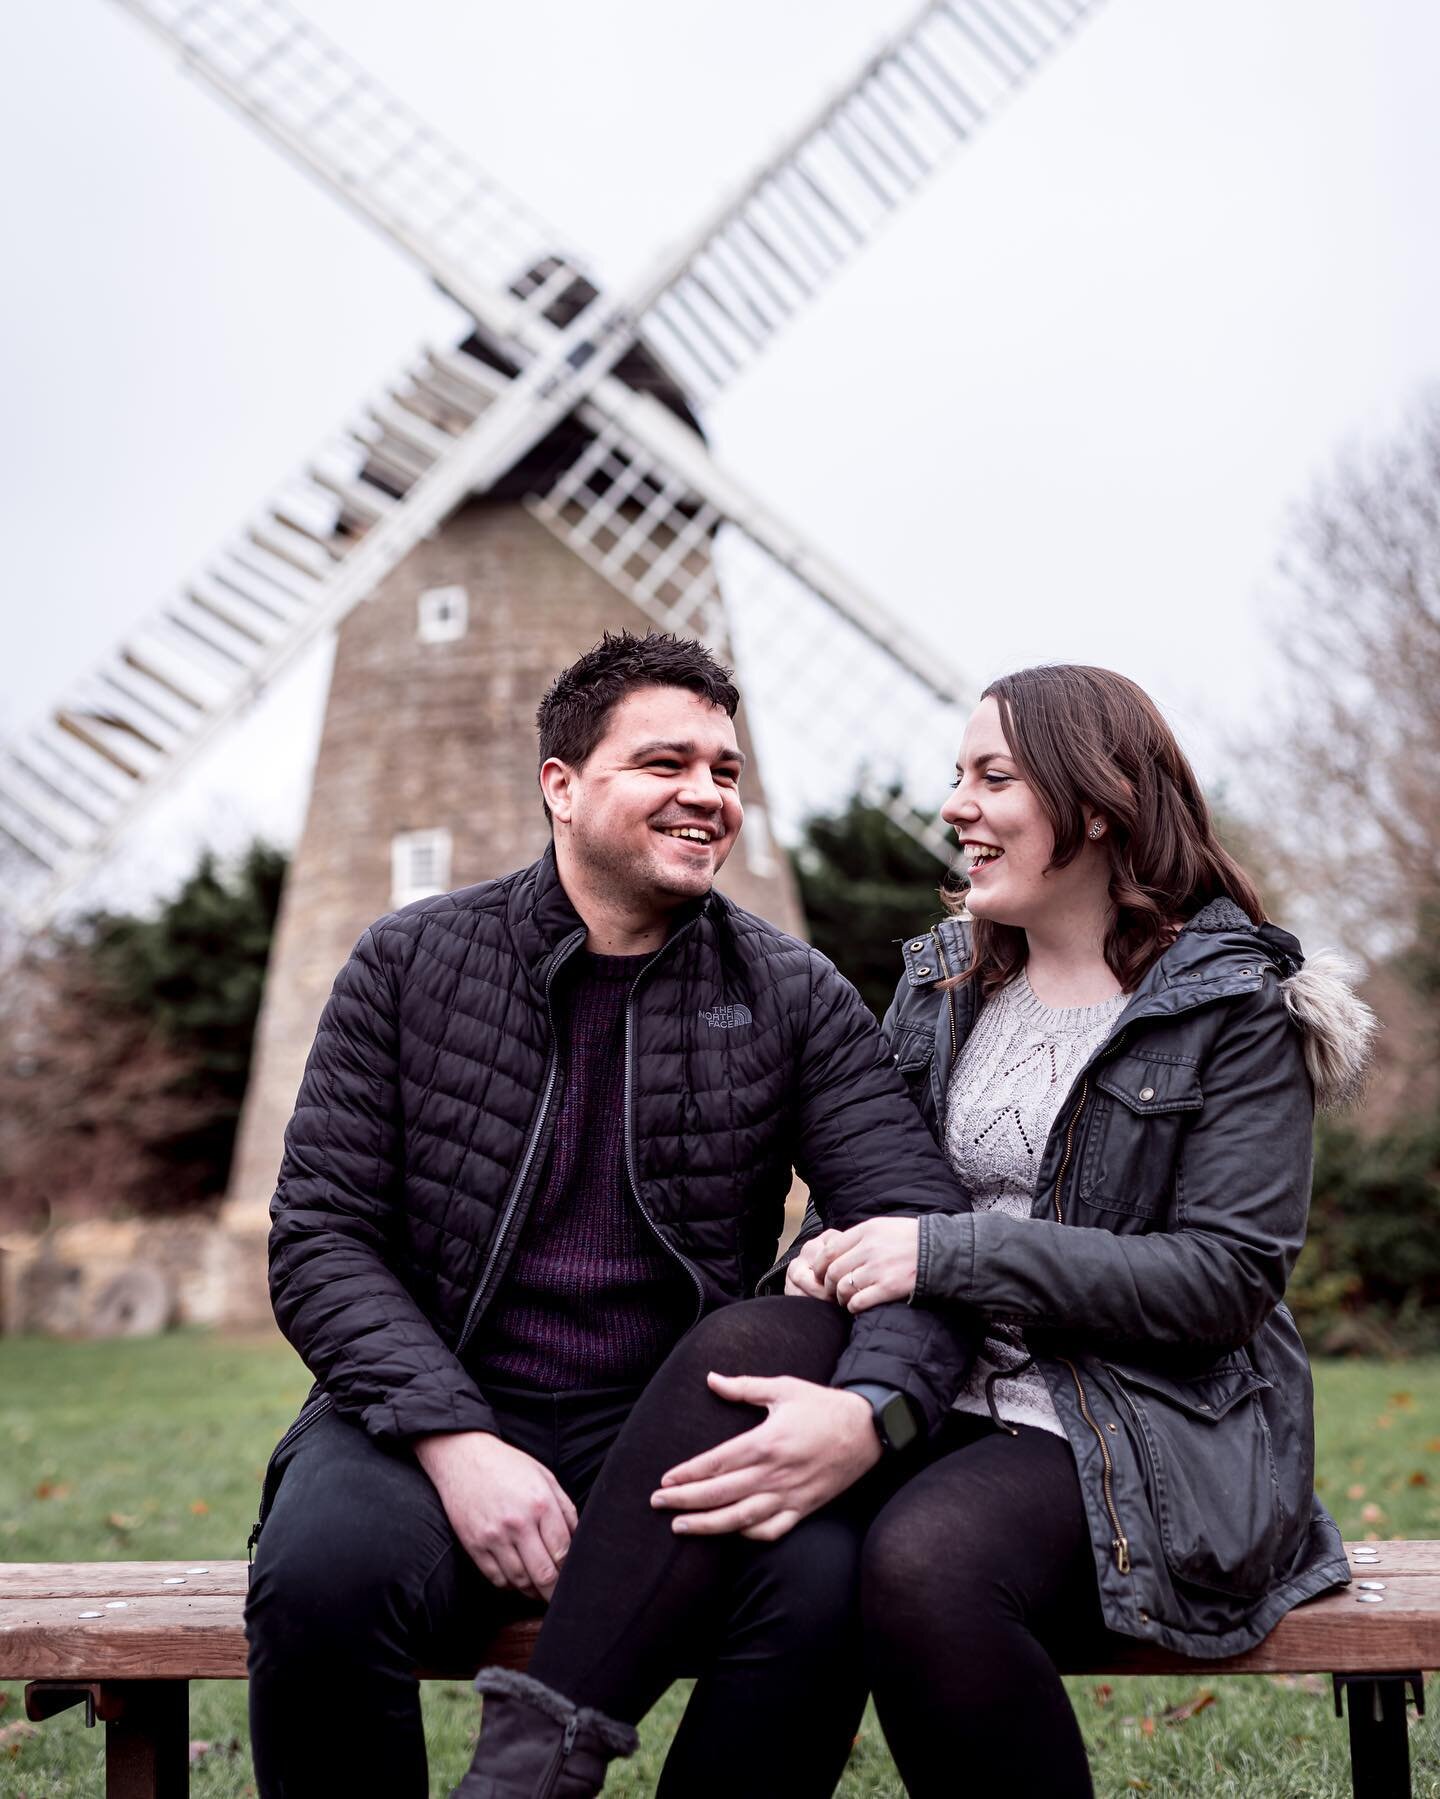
[1080,1054,1204,1218]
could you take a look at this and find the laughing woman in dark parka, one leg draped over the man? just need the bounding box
[461,667,1373,1799]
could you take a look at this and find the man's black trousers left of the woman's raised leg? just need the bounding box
[245,1387,635,1799]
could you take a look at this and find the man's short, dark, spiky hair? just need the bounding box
[535,631,740,819]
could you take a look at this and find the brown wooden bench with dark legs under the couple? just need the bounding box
[0,1542,1440,1799]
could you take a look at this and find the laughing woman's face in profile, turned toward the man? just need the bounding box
[940,698,1103,930]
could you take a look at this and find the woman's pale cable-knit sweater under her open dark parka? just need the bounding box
[945,970,1127,1437]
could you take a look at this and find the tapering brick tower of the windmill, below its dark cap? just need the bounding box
[225,498,803,1324]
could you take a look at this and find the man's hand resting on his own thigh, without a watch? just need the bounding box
[414,1430,576,1599]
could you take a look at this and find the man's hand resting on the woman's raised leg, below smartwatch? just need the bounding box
[650,1374,880,1544]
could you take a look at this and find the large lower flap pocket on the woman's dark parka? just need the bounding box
[1105,1358,1283,1599]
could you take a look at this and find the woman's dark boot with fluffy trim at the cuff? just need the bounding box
[450,1668,639,1799]
